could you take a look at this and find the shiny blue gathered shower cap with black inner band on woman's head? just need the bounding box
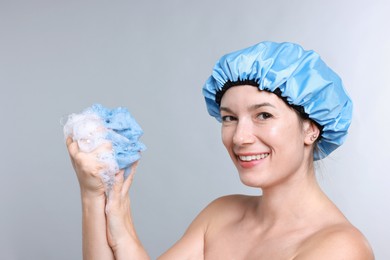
[203,42,352,160]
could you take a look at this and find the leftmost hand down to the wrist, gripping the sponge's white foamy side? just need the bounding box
[66,137,112,197]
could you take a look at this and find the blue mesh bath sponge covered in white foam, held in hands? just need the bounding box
[64,104,146,179]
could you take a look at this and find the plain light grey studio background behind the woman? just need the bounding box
[0,0,390,260]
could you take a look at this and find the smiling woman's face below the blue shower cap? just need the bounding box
[221,85,310,188]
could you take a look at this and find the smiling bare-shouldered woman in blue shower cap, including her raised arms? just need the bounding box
[67,42,374,260]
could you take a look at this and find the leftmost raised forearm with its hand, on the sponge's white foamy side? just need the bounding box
[66,138,114,260]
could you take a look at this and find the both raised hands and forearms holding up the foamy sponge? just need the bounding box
[66,138,149,260]
